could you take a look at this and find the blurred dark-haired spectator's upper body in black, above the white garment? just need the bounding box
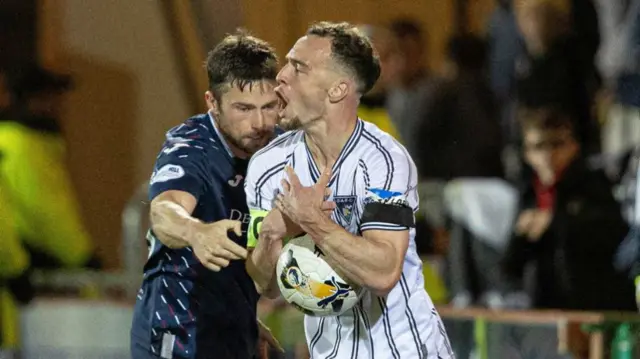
[412,35,503,180]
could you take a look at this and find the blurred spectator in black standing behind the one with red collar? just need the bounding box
[516,0,599,153]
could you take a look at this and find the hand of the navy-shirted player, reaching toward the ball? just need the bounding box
[191,219,247,272]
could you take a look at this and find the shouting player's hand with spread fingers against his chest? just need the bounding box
[275,165,335,225]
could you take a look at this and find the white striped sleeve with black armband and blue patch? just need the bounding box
[360,146,418,232]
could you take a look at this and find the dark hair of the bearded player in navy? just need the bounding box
[206,29,278,99]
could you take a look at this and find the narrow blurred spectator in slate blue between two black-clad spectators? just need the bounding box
[487,0,522,144]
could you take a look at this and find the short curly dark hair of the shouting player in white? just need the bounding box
[307,21,380,94]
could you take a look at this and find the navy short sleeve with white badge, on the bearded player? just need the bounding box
[149,142,212,200]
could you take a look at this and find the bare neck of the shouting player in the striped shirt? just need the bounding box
[304,110,358,171]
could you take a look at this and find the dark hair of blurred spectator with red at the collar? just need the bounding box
[517,107,575,135]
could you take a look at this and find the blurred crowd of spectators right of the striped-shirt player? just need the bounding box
[361,0,640,316]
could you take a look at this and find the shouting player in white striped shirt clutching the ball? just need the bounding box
[245,22,453,359]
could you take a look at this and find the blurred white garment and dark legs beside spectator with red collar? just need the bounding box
[445,178,518,307]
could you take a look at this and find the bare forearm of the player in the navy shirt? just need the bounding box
[151,201,202,248]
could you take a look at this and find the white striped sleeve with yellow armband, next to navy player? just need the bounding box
[244,153,286,248]
